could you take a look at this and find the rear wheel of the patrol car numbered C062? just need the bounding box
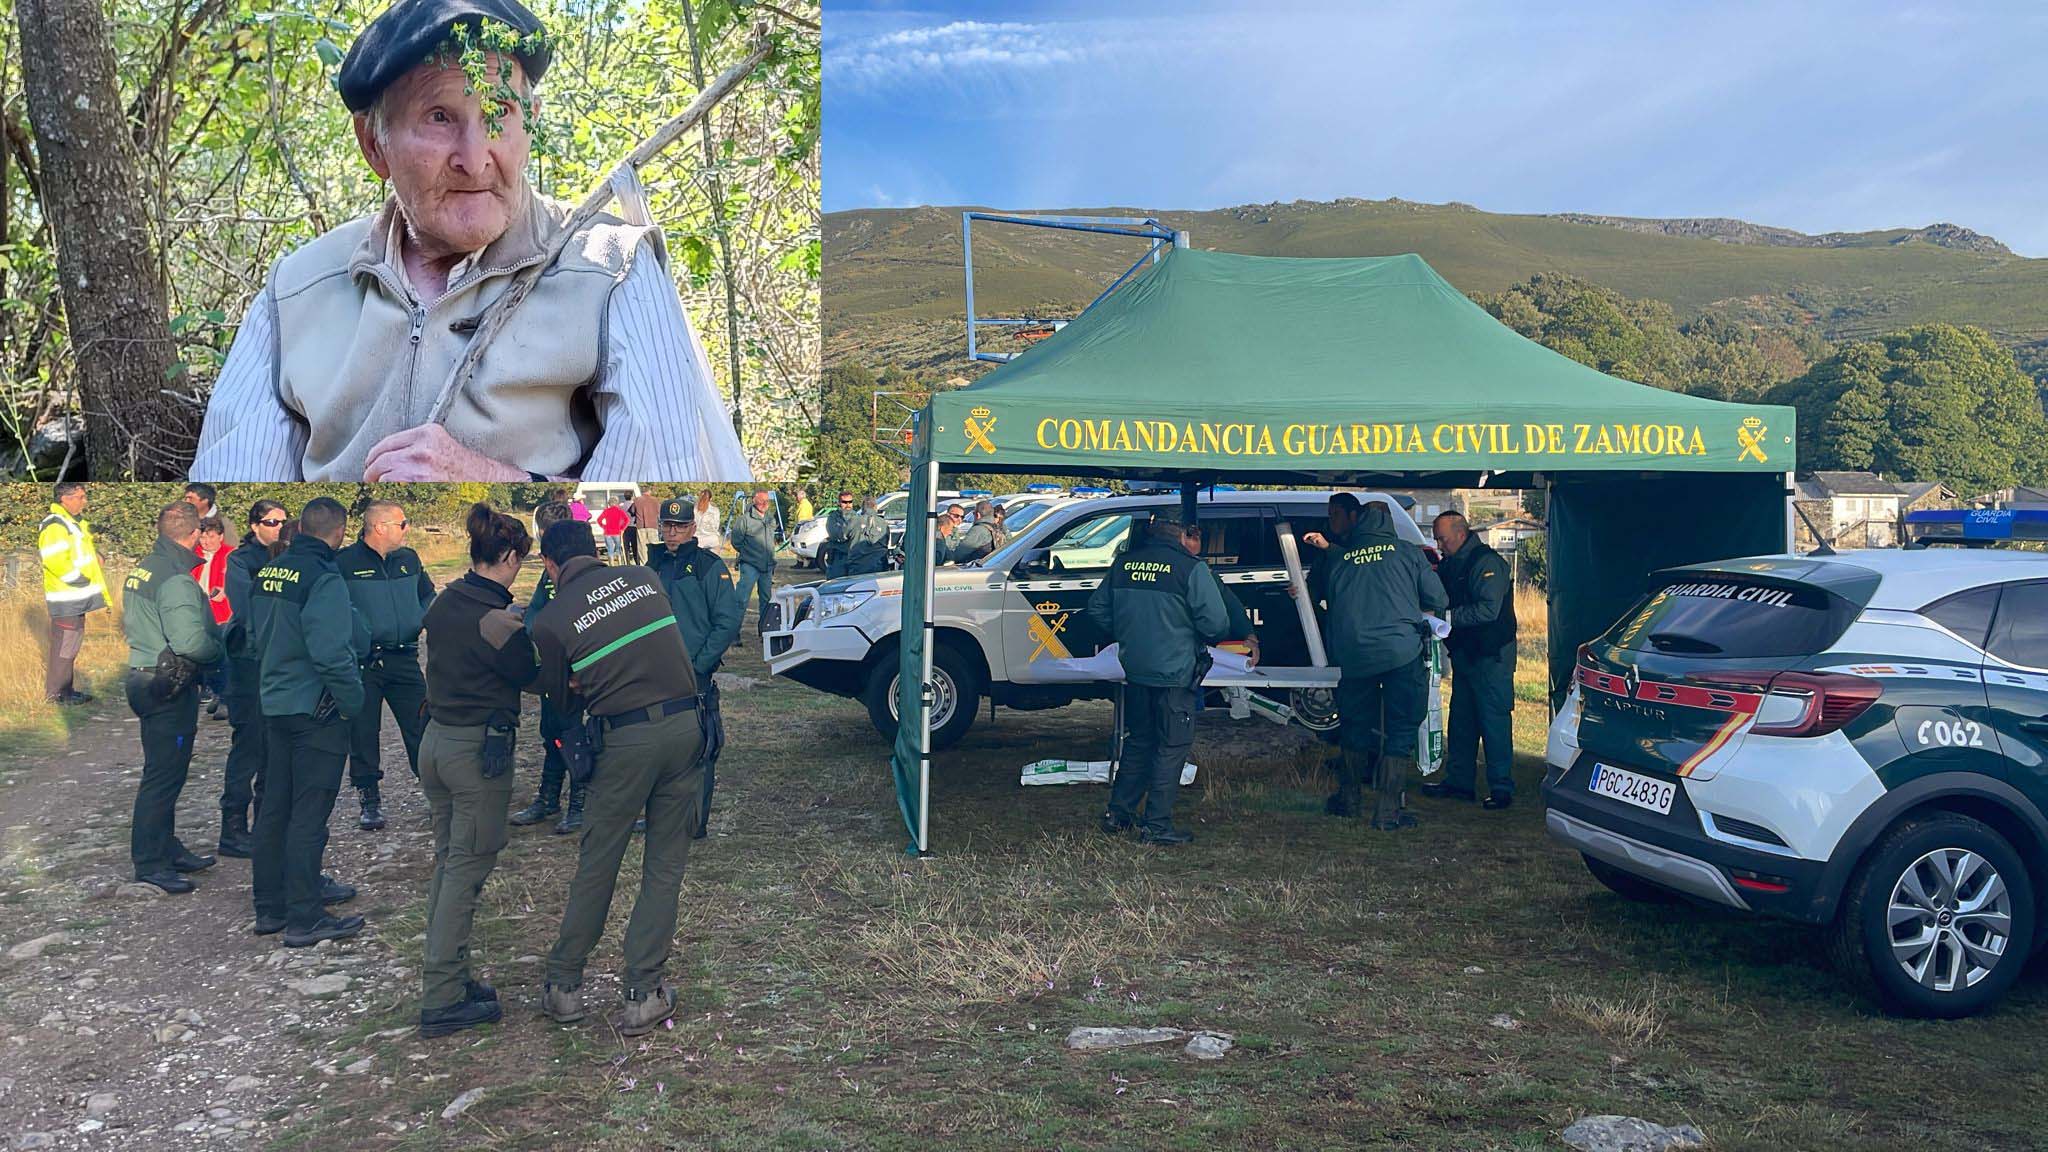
[1835,812,2034,1019]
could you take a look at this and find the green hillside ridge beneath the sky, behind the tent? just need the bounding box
[823,201,2048,375]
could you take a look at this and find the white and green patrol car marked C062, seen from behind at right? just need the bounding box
[1542,549,2048,1017]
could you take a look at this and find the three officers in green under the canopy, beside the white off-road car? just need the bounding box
[1087,492,1516,845]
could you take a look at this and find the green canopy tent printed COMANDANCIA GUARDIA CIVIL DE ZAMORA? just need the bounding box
[893,248,1794,851]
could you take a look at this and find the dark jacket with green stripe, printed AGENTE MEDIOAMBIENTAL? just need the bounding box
[526,556,696,715]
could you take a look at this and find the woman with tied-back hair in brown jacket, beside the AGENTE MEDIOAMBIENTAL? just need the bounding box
[420,504,541,1035]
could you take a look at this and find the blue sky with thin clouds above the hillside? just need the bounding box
[825,0,2048,256]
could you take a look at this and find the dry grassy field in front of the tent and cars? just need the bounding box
[4,564,2048,1150]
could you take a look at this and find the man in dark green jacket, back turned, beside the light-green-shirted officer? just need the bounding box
[250,496,369,947]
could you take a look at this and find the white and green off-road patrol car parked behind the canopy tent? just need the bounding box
[762,492,1427,748]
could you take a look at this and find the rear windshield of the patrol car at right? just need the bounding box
[1608,574,1855,660]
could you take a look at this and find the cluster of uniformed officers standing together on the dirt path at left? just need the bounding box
[123,479,743,1035]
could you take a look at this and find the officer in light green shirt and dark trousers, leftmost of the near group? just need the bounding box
[121,500,221,892]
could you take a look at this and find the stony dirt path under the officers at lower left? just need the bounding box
[0,701,432,1148]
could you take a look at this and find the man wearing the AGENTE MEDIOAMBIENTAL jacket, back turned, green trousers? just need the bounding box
[526,523,705,1035]
